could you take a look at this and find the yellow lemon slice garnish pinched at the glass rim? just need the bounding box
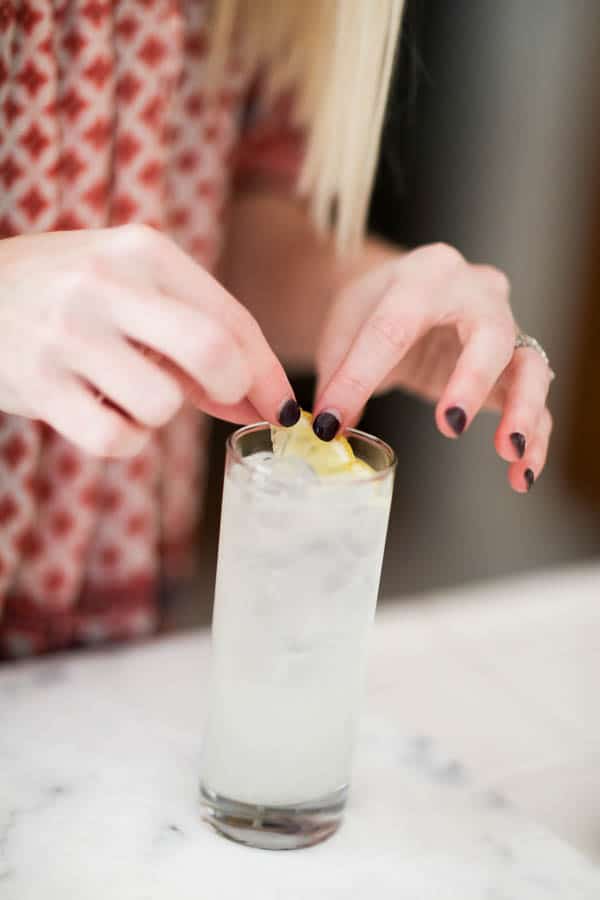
[271,412,374,478]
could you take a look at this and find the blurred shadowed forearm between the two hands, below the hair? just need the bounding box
[222,190,397,372]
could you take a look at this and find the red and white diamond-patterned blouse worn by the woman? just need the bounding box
[0,0,301,658]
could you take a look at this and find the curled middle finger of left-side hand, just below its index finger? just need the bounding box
[106,285,251,404]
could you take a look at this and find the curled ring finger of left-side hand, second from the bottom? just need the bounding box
[64,335,183,428]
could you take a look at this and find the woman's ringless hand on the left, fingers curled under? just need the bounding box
[0,225,295,456]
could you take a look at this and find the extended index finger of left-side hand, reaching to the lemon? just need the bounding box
[114,227,299,424]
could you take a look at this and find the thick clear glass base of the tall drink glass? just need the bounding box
[200,785,348,850]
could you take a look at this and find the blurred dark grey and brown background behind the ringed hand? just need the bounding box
[180,0,600,615]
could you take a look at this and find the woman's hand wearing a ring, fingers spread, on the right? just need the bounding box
[314,244,552,492]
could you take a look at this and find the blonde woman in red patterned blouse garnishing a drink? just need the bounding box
[0,0,551,657]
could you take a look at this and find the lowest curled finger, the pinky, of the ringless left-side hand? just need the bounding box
[39,375,150,457]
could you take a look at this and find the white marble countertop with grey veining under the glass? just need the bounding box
[0,567,600,900]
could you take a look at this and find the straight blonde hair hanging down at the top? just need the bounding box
[212,0,404,250]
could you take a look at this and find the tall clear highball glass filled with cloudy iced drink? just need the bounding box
[201,423,395,849]
